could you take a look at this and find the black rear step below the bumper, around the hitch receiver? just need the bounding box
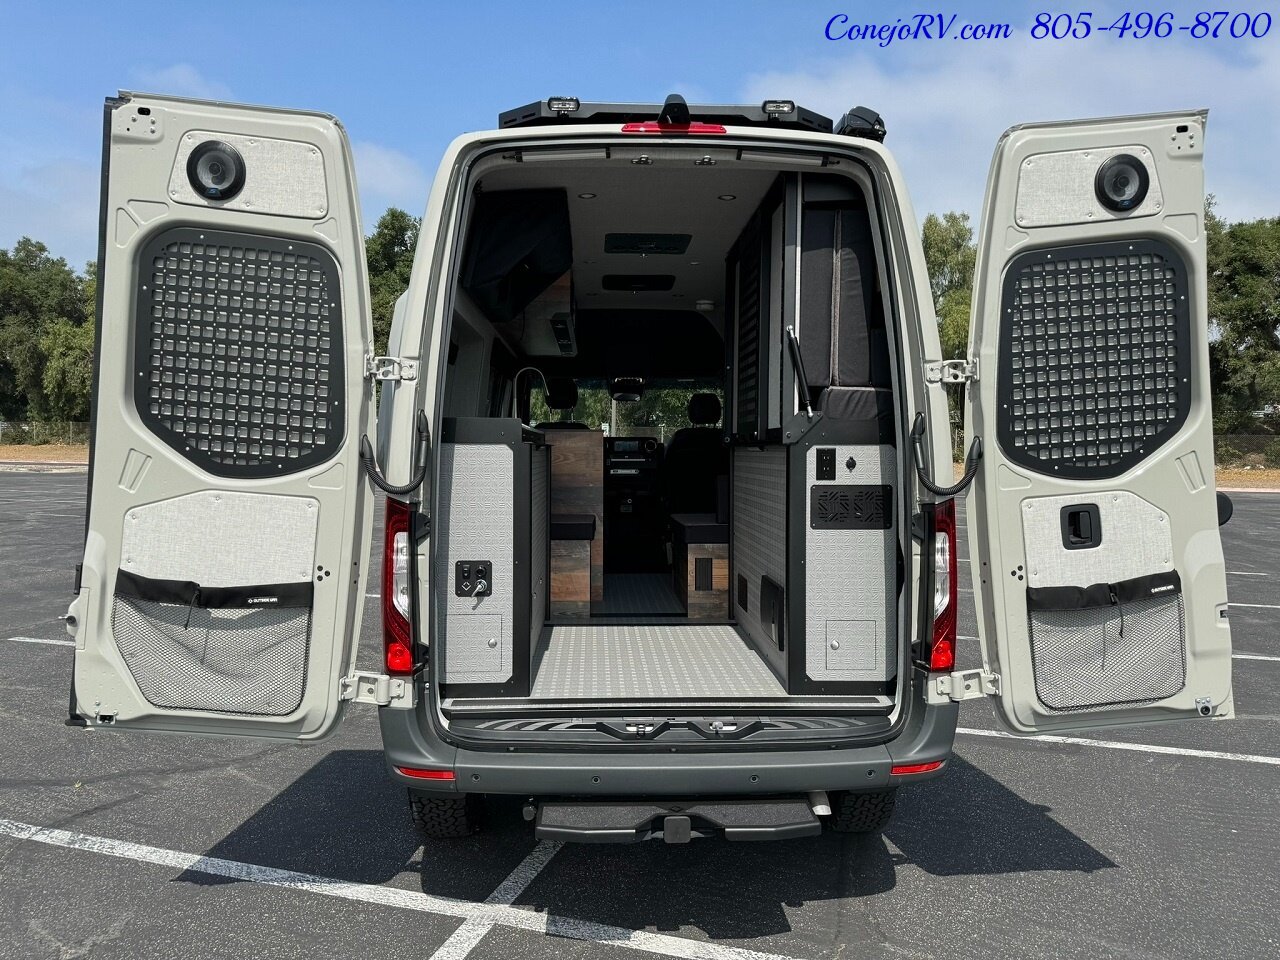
[525,796,822,844]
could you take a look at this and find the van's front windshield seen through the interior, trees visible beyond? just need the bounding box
[529,378,724,443]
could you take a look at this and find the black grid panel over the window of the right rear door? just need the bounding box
[997,241,1190,477]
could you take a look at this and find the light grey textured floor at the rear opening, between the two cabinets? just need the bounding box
[532,623,786,700]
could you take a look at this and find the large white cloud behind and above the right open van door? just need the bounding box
[744,37,1280,220]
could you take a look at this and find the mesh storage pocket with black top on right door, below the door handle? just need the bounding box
[1027,572,1187,712]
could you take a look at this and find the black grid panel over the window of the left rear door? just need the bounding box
[134,228,344,476]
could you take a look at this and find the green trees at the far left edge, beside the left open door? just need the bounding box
[0,237,93,420]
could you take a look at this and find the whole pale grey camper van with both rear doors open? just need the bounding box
[67,93,1233,842]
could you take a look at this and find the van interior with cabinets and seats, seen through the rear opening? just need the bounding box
[430,143,910,718]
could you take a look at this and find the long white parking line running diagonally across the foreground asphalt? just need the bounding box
[0,819,791,960]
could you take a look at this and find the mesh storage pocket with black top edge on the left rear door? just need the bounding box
[111,571,312,717]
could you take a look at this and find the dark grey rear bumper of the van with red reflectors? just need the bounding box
[379,682,959,797]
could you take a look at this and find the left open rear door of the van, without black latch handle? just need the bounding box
[68,93,372,739]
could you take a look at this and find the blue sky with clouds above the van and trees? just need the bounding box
[0,0,1280,265]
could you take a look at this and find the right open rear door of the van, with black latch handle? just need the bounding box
[966,111,1233,732]
